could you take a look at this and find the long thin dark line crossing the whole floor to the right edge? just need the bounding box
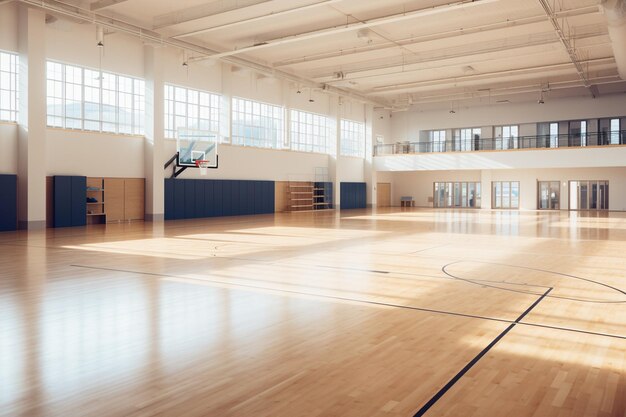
[70,264,626,340]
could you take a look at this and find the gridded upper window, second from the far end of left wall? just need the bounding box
[290,110,335,153]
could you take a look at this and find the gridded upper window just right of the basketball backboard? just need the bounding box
[232,97,285,149]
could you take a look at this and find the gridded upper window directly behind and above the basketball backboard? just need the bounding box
[165,85,221,138]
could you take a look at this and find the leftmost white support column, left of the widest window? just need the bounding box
[17,5,47,230]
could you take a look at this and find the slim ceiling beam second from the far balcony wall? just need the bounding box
[372,57,615,94]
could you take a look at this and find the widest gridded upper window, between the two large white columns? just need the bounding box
[46,61,146,135]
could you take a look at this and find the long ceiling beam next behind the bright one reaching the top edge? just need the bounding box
[273,6,599,68]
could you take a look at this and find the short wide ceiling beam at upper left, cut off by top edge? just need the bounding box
[153,0,273,30]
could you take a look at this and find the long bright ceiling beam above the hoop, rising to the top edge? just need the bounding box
[193,0,500,59]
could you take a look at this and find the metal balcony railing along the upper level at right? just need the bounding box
[374,130,626,156]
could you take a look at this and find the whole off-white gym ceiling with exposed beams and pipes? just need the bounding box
[51,0,626,108]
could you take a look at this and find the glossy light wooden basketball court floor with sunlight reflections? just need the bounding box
[0,209,626,417]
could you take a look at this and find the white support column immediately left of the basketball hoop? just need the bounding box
[144,46,165,222]
